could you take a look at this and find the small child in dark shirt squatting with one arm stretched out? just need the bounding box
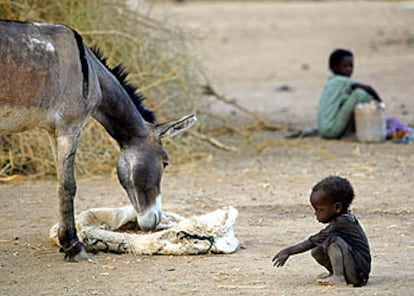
[272,176,371,287]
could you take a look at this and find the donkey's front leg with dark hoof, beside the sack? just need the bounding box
[57,131,89,262]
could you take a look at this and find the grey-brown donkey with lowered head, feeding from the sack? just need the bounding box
[0,20,197,261]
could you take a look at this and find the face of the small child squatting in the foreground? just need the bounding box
[310,190,342,223]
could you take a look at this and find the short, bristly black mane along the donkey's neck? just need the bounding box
[91,47,156,123]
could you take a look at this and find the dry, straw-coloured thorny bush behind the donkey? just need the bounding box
[0,0,278,181]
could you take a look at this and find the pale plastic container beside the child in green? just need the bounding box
[355,101,387,143]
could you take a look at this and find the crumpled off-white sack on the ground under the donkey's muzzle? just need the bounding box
[50,206,240,255]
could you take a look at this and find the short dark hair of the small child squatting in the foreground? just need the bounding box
[312,176,354,210]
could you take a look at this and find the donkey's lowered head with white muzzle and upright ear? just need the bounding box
[117,115,197,230]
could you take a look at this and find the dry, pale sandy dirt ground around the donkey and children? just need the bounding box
[0,1,414,295]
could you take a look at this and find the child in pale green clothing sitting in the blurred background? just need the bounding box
[317,49,381,139]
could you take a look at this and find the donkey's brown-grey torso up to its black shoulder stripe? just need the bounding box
[0,20,87,133]
